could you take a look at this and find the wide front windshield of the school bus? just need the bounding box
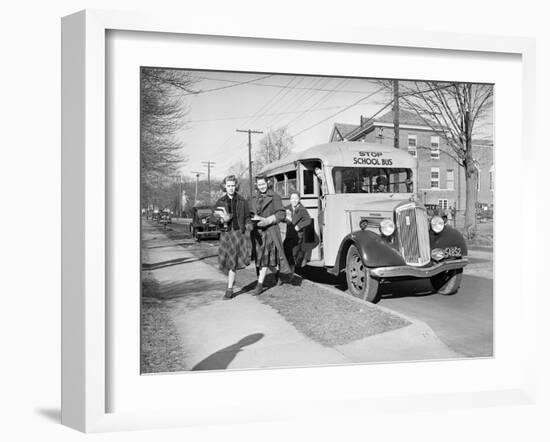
[332,167,413,193]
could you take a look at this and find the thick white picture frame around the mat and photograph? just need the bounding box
[62,10,537,432]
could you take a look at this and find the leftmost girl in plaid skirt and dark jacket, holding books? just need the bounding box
[215,175,251,299]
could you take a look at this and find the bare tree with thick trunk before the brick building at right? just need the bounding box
[381,81,493,238]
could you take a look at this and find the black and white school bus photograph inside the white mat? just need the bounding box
[136,66,495,374]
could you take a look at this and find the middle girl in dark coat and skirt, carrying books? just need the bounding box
[250,176,290,296]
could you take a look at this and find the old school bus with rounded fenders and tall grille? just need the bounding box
[262,142,468,302]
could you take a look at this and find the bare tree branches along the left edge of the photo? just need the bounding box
[140,68,195,209]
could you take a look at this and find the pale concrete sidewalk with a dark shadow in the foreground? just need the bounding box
[143,226,460,370]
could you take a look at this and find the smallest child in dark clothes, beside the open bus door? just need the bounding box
[283,192,311,272]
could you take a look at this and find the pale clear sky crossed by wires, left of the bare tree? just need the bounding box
[177,71,496,179]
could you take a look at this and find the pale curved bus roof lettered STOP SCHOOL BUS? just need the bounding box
[260,141,417,175]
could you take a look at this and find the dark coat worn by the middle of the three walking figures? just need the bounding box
[250,189,290,273]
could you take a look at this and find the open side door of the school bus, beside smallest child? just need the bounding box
[298,163,323,264]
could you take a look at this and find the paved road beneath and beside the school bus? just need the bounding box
[155,219,493,357]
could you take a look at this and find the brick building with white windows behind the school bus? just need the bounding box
[330,111,494,214]
